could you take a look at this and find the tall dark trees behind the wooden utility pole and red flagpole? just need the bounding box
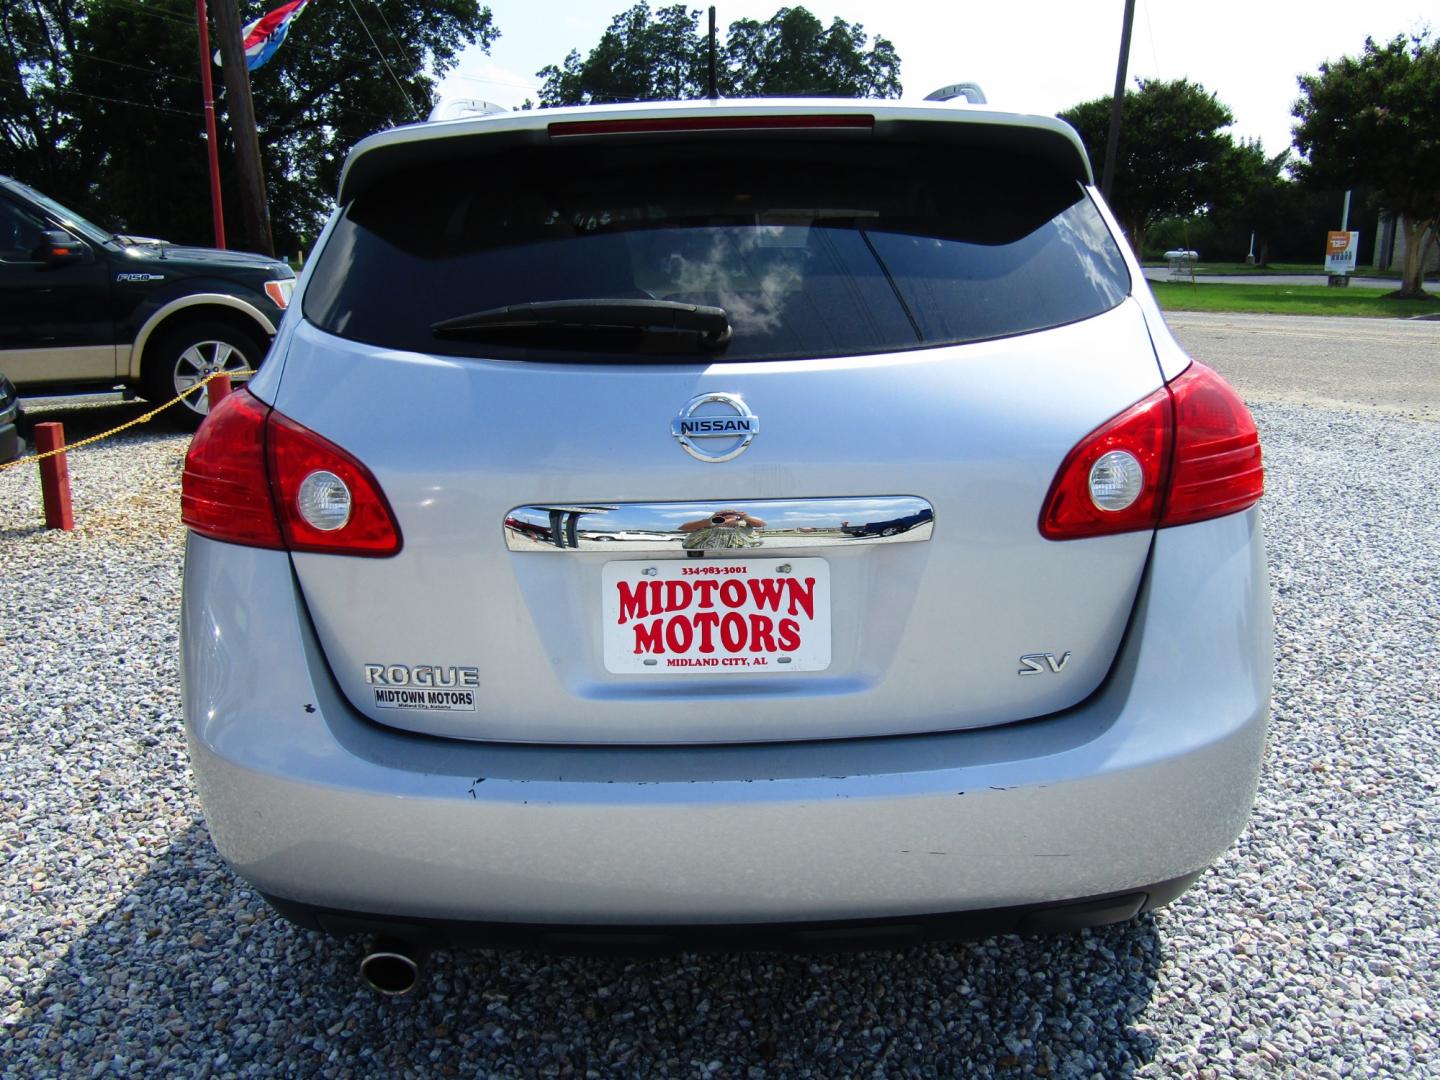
[0,0,497,252]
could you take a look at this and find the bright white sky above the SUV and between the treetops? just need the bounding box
[441,0,1440,154]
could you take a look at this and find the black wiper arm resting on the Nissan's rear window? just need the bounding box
[431,300,730,348]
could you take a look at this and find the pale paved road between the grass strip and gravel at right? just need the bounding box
[1166,311,1440,420]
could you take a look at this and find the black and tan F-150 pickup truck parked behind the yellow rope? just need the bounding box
[0,176,295,422]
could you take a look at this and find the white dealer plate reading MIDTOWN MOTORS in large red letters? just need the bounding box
[600,559,829,675]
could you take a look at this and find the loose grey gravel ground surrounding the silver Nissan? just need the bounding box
[0,405,1440,1077]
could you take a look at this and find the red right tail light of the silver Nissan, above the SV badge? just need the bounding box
[1040,363,1264,540]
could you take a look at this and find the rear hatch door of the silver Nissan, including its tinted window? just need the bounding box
[275,118,1161,743]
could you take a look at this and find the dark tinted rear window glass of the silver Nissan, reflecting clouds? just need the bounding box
[304,141,1130,361]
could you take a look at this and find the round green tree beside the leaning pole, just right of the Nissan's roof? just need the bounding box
[1060,79,1244,256]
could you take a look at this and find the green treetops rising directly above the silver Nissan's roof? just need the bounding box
[536,3,900,107]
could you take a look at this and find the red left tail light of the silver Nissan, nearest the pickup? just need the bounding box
[180,389,400,557]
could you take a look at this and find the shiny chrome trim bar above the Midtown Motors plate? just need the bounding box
[504,495,935,557]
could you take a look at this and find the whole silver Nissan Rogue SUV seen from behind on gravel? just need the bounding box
[183,101,1272,991]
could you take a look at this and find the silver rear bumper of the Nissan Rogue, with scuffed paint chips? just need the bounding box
[181,511,1272,939]
